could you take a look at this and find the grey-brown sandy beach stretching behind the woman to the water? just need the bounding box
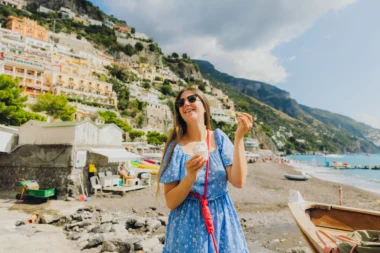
[0,163,380,253]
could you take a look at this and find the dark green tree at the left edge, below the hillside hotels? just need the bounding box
[0,75,46,126]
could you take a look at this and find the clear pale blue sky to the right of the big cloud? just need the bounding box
[273,0,380,128]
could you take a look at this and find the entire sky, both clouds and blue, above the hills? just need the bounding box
[92,0,380,128]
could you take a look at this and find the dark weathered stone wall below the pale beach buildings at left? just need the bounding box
[0,145,122,199]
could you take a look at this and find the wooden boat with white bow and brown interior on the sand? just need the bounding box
[288,191,380,253]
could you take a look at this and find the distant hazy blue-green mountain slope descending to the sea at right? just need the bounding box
[194,60,380,153]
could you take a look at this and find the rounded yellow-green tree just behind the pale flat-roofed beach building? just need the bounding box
[30,93,76,121]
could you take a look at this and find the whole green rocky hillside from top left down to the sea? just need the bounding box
[0,0,380,153]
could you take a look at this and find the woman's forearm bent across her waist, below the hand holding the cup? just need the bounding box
[165,176,196,210]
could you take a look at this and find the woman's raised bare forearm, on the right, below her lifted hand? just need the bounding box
[229,138,247,188]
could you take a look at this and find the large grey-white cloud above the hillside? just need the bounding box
[104,0,355,84]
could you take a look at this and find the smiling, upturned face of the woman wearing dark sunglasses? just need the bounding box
[179,91,206,124]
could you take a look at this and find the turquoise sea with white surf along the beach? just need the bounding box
[287,155,380,193]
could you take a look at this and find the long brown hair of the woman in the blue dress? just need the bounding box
[156,88,211,196]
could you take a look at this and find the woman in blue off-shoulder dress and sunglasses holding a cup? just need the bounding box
[157,88,252,253]
